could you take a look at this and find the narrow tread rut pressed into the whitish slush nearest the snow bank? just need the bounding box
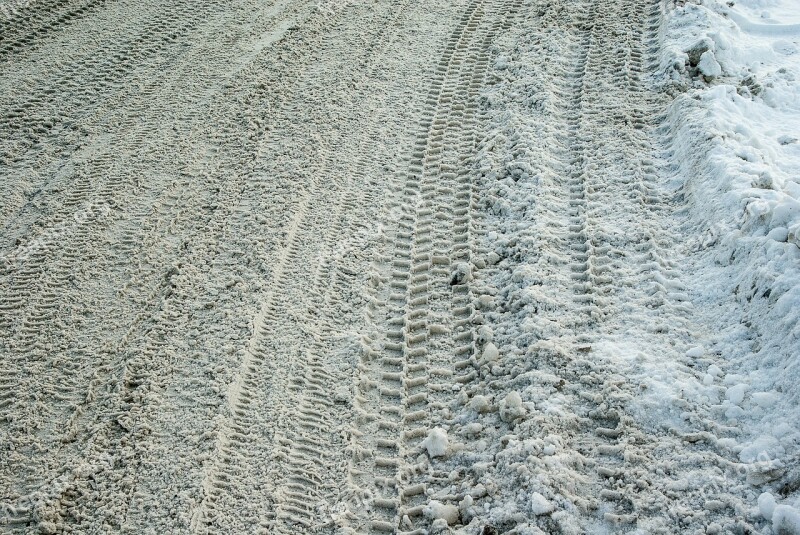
[538,2,664,527]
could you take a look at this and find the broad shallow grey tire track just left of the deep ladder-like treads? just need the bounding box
[188,4,484,533]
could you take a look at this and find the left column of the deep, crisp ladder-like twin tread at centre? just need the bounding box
[352,1,494,532]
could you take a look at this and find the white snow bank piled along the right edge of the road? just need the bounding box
[659,0,800,533]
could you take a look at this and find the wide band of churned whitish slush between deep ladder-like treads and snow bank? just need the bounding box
[466,1,748,532]
